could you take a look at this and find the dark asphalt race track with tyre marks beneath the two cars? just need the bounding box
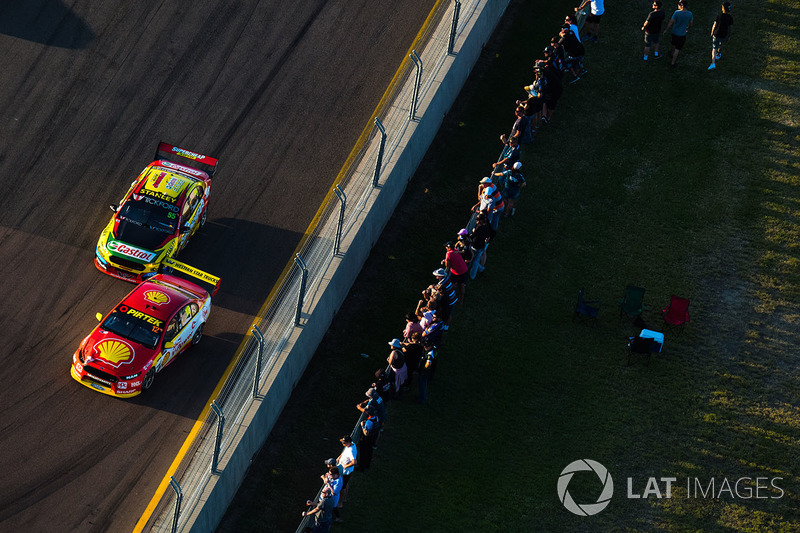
[0,0,434,532]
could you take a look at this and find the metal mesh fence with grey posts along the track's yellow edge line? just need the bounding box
[143,0,481,532]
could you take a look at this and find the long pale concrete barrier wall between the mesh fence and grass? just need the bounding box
[181,0,509,532]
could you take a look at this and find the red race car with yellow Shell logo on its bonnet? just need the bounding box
[70,258,220,398]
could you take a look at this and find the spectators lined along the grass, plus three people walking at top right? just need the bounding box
[303,0,733,533]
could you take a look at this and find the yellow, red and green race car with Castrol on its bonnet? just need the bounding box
[94,142,219,283]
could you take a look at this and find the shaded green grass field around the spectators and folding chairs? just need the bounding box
[220,0,800,532]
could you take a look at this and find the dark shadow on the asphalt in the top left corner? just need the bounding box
[0,0,95,48]
